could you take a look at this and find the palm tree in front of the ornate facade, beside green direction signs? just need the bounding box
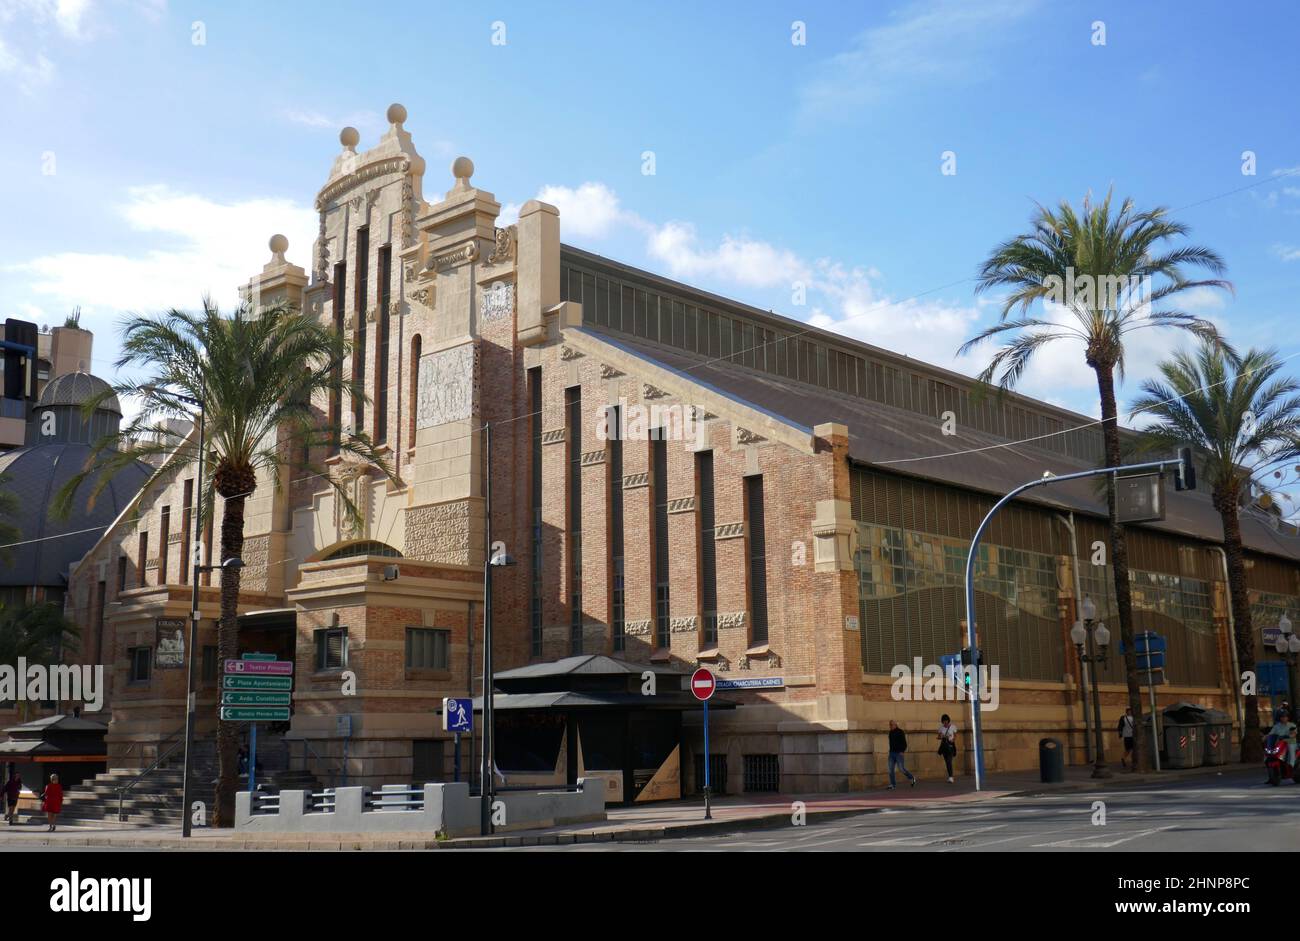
[55,298,391,827]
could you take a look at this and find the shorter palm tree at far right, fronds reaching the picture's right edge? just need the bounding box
[1132,342,1300,762]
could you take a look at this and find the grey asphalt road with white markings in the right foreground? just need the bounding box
[504,772,1300,853]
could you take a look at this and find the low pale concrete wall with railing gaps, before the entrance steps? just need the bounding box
[235,780,606,837]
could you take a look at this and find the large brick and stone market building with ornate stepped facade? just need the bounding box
[58,105,1300,801]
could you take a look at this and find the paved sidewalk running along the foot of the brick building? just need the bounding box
[0,763,1258,851]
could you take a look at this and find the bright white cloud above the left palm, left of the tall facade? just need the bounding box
[0,185,319,324]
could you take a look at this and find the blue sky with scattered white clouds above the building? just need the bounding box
[0,0,1300,454]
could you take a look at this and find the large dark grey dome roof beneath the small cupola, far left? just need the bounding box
[0,441,153,586]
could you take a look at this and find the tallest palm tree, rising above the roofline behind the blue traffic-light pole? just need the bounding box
[961,192,1231,767]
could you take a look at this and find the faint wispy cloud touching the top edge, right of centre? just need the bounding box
[801,0,1036,118]
